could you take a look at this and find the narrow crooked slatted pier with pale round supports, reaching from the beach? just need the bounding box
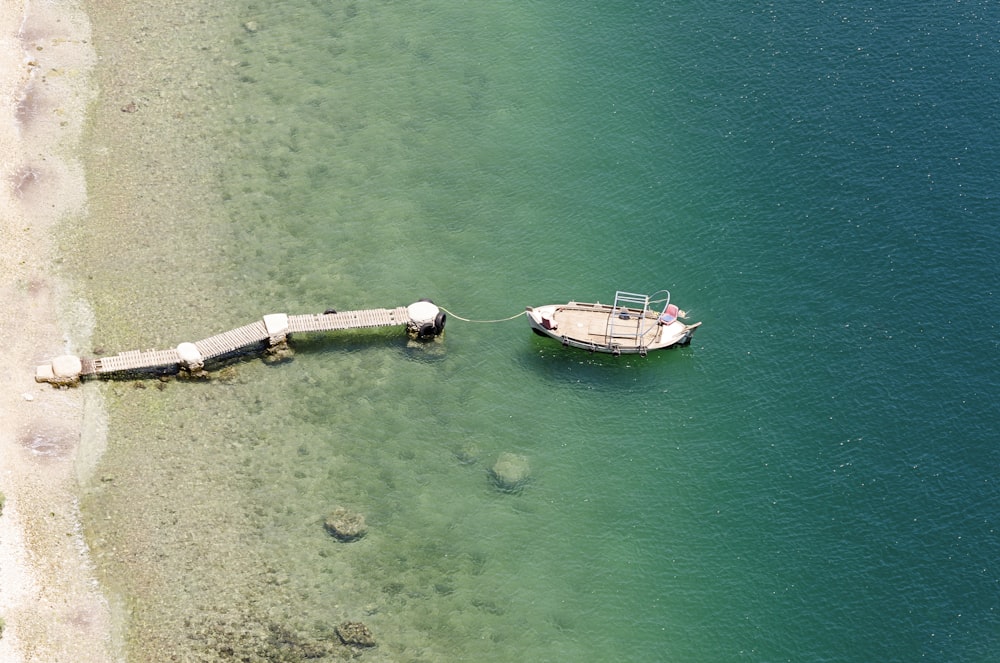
[35,299,446,386]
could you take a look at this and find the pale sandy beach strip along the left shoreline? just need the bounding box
[0,0,116,662]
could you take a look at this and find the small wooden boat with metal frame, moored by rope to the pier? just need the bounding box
[525,290,701,356]
